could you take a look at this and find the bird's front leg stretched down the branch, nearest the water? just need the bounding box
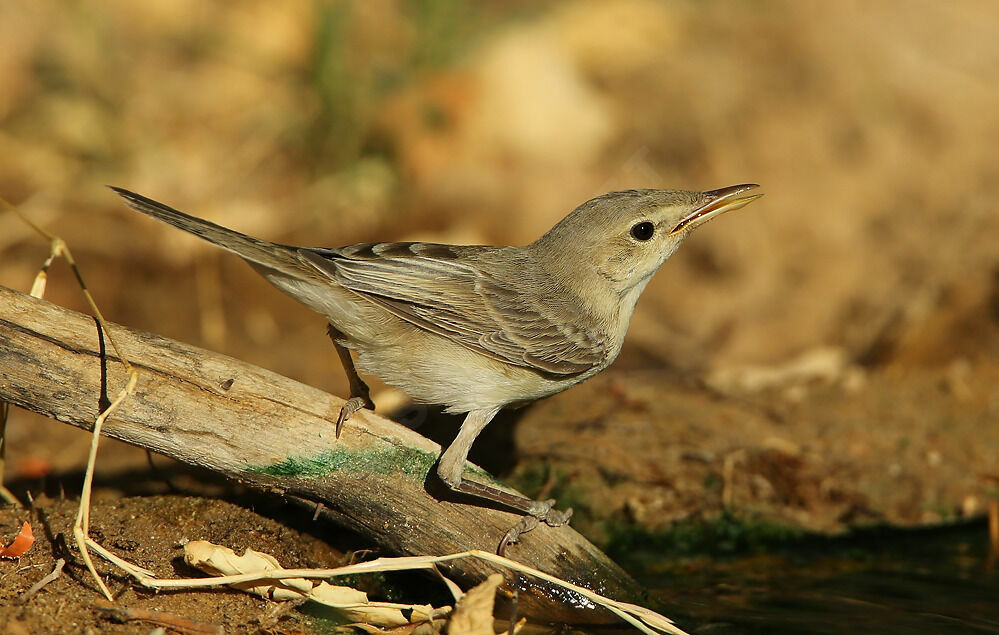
[437,408,572,550]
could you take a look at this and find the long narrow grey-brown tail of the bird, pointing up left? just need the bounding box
[108,185,302,272]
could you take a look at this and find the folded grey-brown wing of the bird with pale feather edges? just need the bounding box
[299,243,606,375]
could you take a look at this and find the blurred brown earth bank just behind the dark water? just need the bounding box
[516,362,999,543]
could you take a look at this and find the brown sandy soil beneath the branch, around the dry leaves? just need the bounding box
[0,495,332,633]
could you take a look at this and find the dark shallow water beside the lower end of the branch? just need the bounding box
[632,523,999,634]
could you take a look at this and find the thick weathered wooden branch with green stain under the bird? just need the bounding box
[0,287,641,623]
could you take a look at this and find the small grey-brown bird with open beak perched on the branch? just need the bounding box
[109,184,762,552]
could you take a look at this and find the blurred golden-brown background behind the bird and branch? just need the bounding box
[0,0,999,560]
